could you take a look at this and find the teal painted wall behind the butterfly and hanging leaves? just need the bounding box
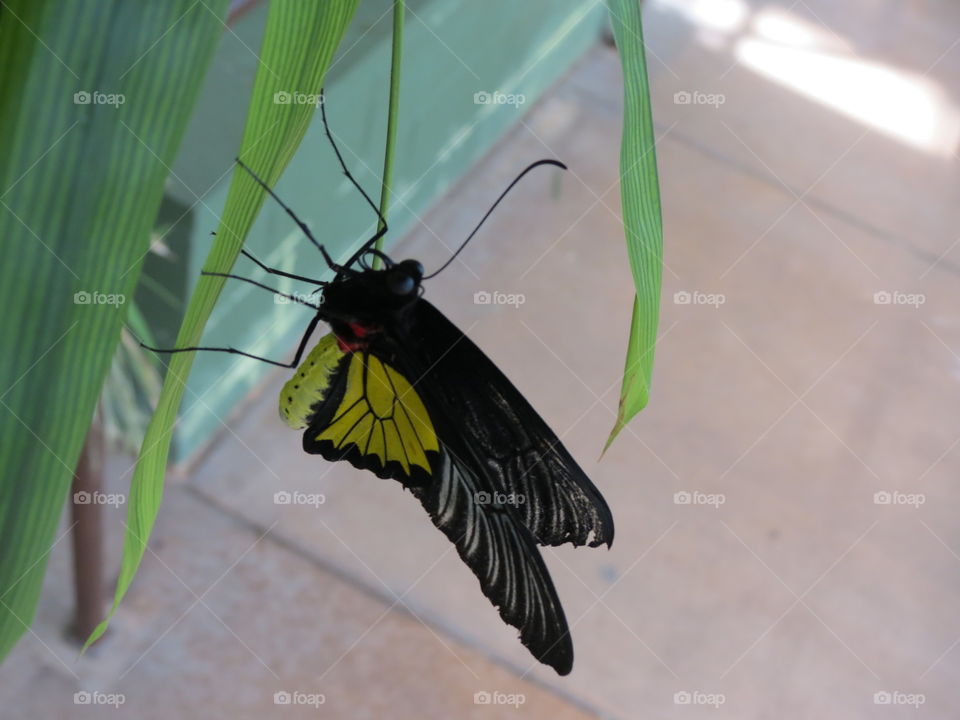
[138,0,605,462]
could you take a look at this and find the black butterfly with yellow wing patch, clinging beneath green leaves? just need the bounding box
[150,91,613,675]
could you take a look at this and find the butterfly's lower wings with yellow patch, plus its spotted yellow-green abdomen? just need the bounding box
[290,335,573,675]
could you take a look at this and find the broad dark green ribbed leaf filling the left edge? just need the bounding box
[0,0,227,658]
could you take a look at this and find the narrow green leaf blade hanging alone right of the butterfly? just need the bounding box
[604,0,663,450]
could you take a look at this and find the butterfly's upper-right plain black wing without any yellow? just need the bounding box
[397,298,613,546]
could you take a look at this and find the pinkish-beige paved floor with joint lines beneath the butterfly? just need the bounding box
[0,0,960,719]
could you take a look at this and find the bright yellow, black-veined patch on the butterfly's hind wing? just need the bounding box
[315,352,440,475]
